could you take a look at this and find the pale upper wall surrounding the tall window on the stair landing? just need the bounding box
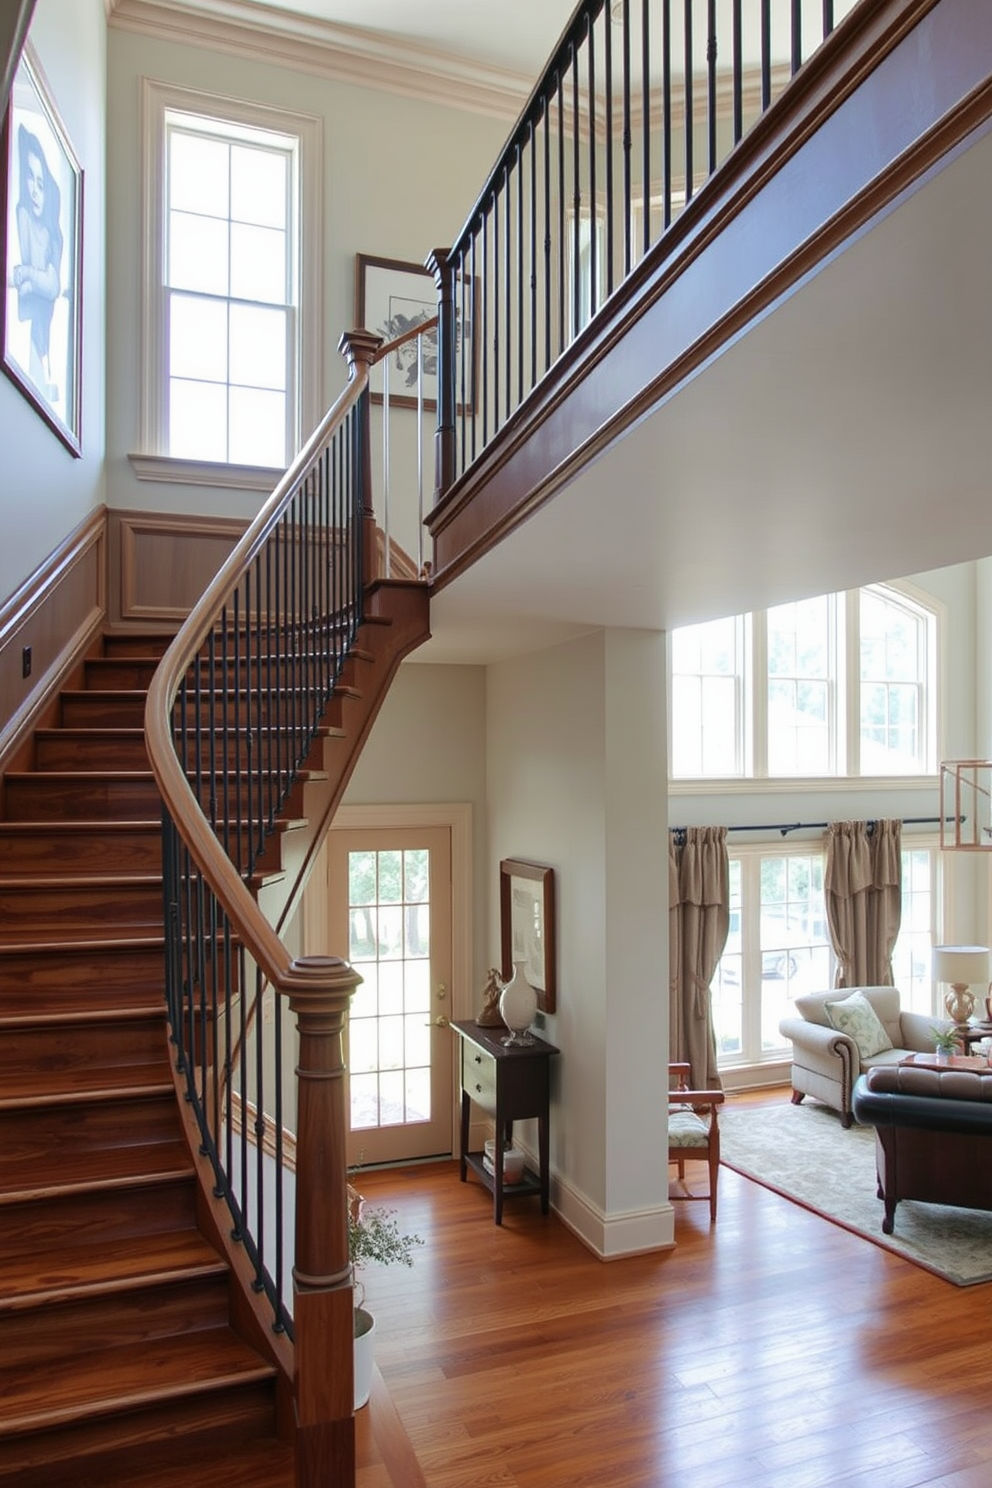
[107,27,506,526]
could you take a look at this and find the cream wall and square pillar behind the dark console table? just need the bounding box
[486,631,672,1254]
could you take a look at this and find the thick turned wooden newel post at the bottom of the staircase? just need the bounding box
[286,955,361,1488]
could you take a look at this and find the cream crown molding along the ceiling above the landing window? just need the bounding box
[107,0,534,122]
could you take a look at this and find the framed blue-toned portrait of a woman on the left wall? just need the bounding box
[0,46,83,455]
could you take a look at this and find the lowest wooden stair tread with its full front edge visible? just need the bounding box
[0,1327,275,1440]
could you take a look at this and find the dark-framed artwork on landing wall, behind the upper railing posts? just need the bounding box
[355,253,474,414]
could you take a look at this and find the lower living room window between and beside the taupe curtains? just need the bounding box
[712,845,938,1065]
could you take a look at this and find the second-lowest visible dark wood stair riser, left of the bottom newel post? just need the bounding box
[0,1273,229,1369]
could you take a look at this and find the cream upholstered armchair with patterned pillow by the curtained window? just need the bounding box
[778,987,947,1126]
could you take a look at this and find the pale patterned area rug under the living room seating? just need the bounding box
[720,1101,992,1287]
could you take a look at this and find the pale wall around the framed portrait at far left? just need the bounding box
[0,0,106,601]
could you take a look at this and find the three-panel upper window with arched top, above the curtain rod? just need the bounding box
[669,585,937,780]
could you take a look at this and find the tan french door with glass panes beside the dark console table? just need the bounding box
[327,827,452,1167]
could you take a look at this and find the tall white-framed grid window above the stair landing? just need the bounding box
[136,83,320,469]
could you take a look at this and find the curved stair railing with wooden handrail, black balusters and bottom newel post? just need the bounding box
[146,321,436,1482]
